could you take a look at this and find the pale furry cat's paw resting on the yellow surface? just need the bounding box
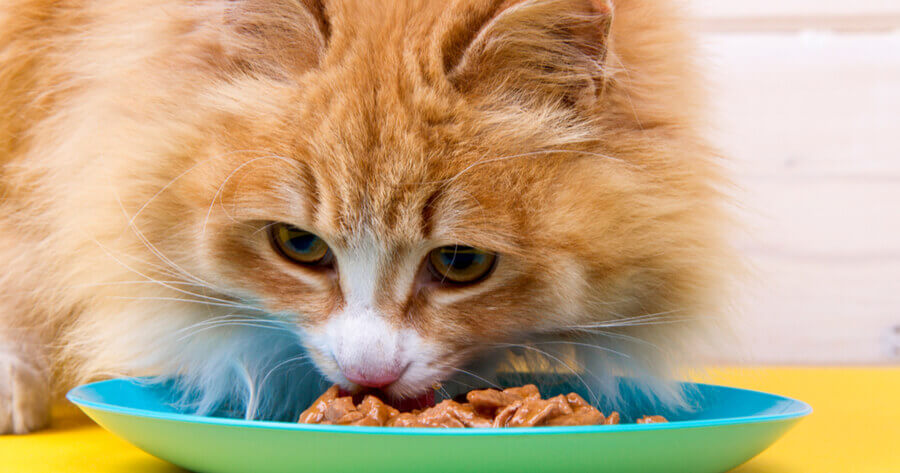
[0,350,50,435]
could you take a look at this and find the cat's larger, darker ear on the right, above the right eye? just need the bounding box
[444,0,612,105]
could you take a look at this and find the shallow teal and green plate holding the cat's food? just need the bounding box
[68,379,812,473]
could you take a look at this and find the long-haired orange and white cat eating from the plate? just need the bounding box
[0,0,733,433]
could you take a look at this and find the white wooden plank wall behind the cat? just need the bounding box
[689,0,900,363]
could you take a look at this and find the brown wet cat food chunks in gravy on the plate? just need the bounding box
[299,384,666,427]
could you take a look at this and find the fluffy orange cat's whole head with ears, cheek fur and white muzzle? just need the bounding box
[148,0,720,402]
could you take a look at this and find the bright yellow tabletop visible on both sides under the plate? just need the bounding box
[0,367,900,473]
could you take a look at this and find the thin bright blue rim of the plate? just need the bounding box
[66,377,813,436]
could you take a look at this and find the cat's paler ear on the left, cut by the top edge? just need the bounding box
[213,0,330,75]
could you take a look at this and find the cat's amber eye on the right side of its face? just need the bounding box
[428,245,497,284]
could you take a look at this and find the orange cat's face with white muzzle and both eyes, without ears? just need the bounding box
[190,85,612,395]
